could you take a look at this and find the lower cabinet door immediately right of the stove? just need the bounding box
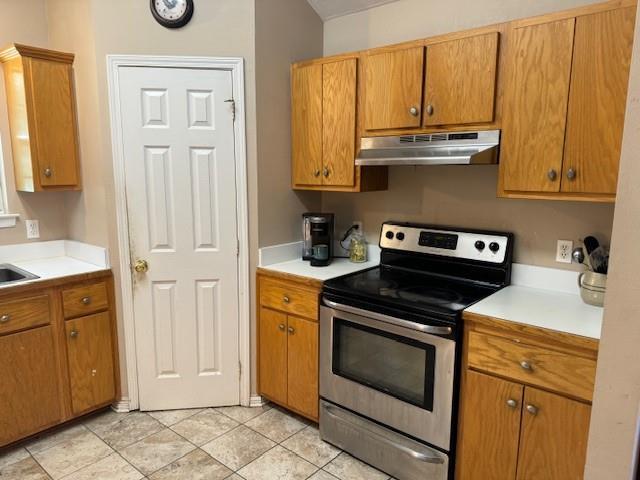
[456,370,524,480]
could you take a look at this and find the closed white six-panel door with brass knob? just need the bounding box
[120,67,239,410]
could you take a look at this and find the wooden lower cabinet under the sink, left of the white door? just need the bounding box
[0,271,120,448]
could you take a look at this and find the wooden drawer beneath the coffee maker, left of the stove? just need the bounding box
[260,278,318,320]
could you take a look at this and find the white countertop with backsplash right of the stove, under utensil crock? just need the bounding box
[466,265,603,339]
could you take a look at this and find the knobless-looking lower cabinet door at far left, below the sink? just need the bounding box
[0,326,62,447]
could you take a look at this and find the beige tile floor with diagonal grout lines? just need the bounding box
[0,406,396,480]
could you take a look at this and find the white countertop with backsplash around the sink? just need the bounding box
[0,240,109,288]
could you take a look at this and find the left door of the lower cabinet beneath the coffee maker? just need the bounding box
[258,307,287,405]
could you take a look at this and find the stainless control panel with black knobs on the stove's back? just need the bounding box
[380,223,509,263]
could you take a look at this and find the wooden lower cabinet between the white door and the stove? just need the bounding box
[258,271,321,421]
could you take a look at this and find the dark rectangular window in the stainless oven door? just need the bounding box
[333,317,436,411]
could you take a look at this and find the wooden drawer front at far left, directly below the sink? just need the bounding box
[0,295,51,335]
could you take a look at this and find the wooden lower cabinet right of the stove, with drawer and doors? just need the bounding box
[456,313,598,480]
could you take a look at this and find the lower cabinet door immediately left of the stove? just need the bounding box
[287,315,318,420]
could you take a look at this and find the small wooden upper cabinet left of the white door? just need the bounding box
[0,44,80,192]
